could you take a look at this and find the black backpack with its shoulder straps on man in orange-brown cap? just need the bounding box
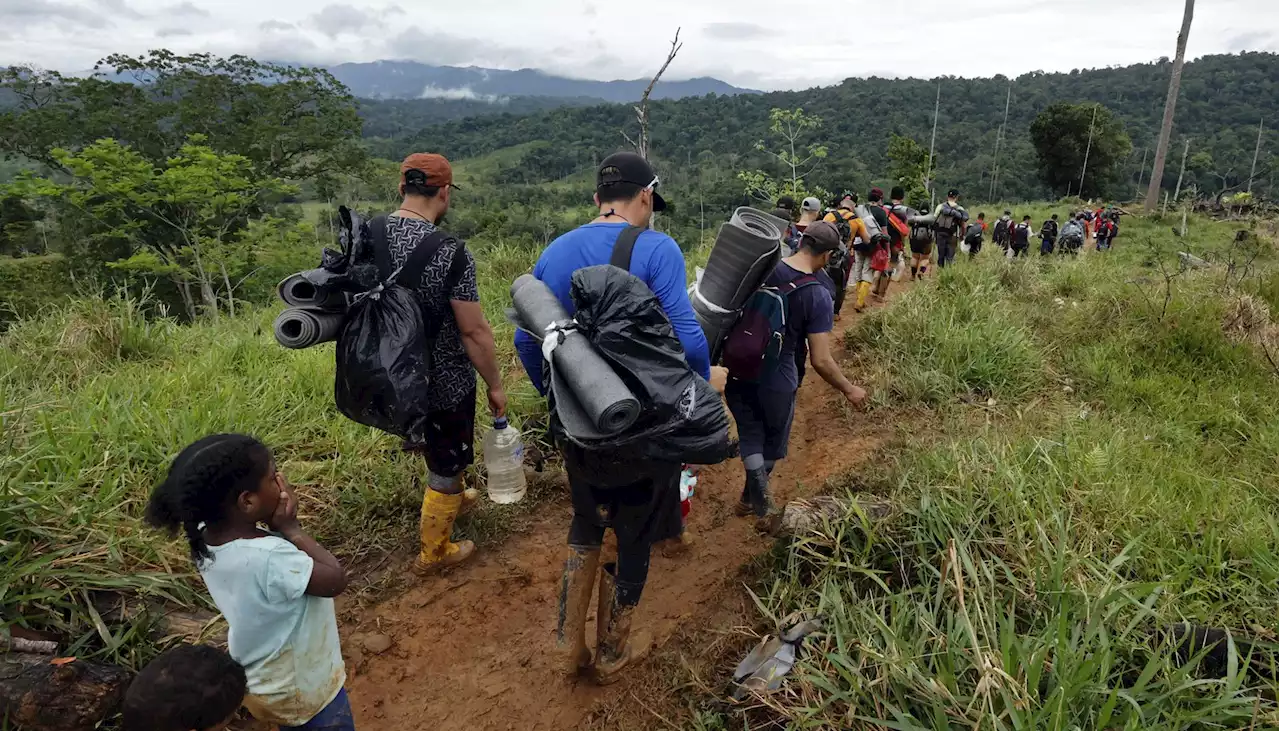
[334,216,467,447]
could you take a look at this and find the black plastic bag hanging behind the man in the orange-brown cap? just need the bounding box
[334,284,430,446]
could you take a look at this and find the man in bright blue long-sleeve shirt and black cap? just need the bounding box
[516,152,723,685]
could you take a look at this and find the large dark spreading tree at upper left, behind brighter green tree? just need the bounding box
[0,50,365,179]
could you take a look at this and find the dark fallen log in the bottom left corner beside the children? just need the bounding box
[0,653,133,731]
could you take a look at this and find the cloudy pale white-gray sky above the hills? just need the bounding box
[0,0,1280,88]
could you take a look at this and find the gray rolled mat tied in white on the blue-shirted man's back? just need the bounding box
[511,274,640,439]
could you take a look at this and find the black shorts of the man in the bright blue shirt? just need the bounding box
[562,447,685,545]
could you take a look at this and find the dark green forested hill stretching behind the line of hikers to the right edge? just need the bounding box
[371,52,1280,198]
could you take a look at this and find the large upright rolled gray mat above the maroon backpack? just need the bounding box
[695,209,782,310]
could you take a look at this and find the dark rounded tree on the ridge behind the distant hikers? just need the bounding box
[1030,102,1133,197]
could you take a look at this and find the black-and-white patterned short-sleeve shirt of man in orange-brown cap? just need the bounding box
[387,215,480,410]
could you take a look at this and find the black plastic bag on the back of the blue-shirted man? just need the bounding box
[552,265,737,465]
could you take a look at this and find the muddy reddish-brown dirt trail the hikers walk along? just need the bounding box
[342,282,910,731]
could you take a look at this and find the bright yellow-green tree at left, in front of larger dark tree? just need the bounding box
[14,136,291,317]
